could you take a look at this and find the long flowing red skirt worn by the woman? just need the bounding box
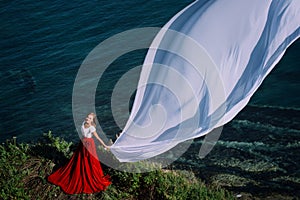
[48,138,111,194]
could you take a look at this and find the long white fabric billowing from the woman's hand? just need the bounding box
[111,0,300,162]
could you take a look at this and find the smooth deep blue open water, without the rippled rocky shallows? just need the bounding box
[0,0,300,141]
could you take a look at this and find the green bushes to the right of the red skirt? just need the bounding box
[104,166,234,200]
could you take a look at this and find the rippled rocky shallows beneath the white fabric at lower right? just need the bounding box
[174,106,300,199]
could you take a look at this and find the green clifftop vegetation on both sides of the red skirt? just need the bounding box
[0,132,234,200]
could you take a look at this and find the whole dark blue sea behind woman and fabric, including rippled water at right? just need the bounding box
[0,0,300,194]
